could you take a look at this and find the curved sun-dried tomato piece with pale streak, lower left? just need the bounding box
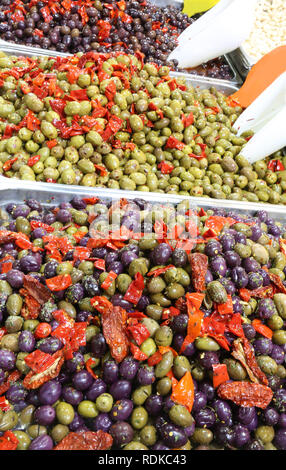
[23,349,64,389]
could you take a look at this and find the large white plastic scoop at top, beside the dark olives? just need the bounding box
[168,0,257,68]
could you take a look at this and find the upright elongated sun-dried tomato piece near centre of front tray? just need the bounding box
[101,306,129,362]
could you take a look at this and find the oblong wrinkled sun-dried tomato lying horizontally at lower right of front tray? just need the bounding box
[217,381,273,409]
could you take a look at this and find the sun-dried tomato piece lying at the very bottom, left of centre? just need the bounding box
[54,430,113,450]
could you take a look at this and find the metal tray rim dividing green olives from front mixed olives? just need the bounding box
[0,177,286,223]
